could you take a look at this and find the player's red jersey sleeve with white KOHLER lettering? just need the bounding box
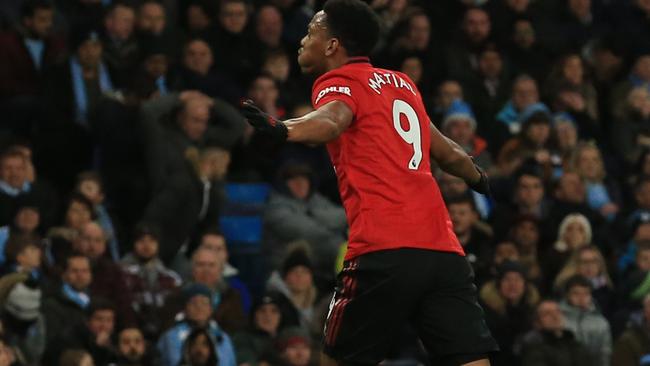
[311,74,360,115]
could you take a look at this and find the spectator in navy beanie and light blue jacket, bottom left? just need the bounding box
[157,283,237,366]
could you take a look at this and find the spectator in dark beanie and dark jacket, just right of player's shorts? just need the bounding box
[479,260,539,365]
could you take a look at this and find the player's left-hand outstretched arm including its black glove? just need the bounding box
[242,100,354,145]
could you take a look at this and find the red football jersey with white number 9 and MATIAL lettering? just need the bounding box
[312,62,458,259]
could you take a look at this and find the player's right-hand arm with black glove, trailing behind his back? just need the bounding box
[430,123,490,194]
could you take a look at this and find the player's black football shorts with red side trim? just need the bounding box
[324,248,498,365]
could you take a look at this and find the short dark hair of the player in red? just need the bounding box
[323,0,380,56]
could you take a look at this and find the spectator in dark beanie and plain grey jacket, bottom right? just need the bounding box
[560,275,612,366]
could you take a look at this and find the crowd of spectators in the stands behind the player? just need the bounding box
[0,0,650,366]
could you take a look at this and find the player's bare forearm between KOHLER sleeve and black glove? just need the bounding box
[284,100,354,144]
